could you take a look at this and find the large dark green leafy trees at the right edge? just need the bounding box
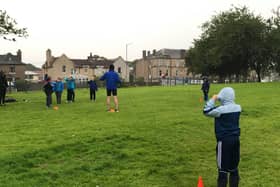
[185,7,280,82]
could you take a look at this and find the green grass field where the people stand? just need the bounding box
[0,83,280,187]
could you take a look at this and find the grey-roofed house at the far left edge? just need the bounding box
[0,50,26,82]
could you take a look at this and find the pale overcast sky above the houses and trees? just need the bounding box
[0,0,280,67]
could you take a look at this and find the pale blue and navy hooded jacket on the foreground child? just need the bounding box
[203,87,241,141]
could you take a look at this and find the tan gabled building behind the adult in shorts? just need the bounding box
[42,49,129,82]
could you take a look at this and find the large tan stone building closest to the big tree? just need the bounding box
[135,49,187,82]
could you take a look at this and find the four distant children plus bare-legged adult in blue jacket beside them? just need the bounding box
[43,64,121,112]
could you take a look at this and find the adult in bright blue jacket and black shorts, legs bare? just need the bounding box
[100,64,121,112]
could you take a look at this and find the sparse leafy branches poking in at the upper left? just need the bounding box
[0,10,28,41]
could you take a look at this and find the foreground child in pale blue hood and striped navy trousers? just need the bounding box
[203,87,241,187]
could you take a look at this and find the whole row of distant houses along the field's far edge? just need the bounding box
[0,49,188,82]
